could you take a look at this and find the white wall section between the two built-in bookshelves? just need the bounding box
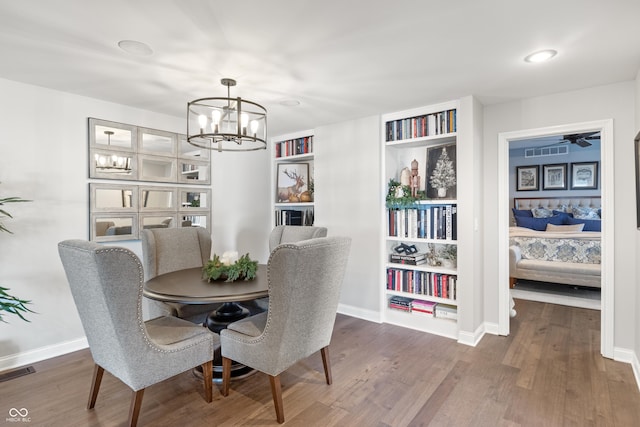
[314,116,384,320]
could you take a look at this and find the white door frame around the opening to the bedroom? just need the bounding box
[498,119,615,358]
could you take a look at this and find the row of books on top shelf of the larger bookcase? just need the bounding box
[386,109,457,142]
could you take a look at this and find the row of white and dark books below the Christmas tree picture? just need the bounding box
[387,205,458,240]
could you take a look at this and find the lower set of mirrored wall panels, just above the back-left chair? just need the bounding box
[89,183,211,242]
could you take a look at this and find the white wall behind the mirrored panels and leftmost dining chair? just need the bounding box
[0,79,270,370]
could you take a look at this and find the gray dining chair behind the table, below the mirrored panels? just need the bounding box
[141,227,220,323]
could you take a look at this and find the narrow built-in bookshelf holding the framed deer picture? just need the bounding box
[271,130,315,226]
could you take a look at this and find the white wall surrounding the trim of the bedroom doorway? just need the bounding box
[484,81,637,350]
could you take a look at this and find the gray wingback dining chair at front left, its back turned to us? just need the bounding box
[58,240,220,426]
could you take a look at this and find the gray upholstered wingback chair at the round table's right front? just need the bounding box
[220,237,351,423]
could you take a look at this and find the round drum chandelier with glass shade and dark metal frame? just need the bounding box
[187,79,267,151]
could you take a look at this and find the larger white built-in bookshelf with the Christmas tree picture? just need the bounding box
[381,102,463,339]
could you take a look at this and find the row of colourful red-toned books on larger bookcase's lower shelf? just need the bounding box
[387,268,458,301]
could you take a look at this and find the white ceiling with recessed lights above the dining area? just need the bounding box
[0,0,640,135]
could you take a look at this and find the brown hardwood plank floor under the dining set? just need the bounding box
[0,300,640,427]
